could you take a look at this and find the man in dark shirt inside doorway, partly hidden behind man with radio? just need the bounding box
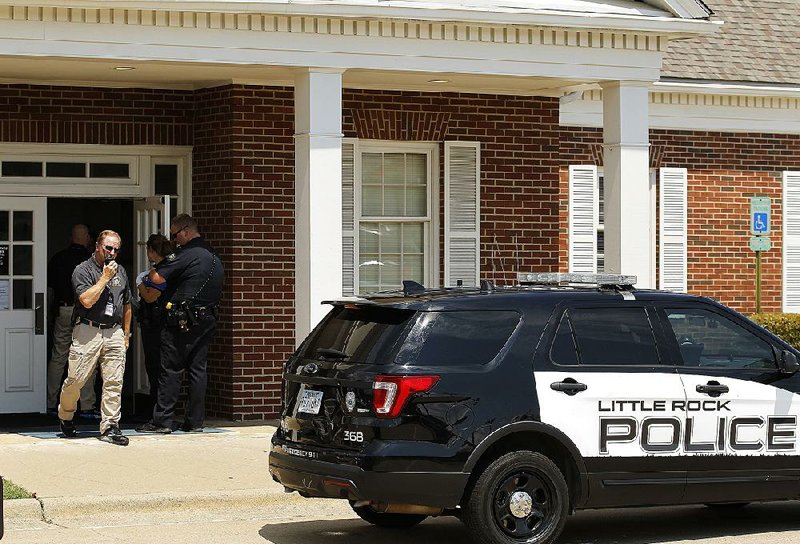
[47,223,97,415]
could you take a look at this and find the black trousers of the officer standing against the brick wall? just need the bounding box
[153,315,217,428]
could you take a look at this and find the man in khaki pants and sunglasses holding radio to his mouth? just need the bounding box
[58,230,131,446]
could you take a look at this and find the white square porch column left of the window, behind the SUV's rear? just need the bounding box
[294,68,342,345]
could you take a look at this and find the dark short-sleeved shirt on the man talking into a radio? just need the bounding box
[72,255,131,325]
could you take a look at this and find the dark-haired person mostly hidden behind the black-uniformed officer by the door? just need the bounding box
[136,234,175,412]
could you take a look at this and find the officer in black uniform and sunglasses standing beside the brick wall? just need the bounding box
[136,214,224,434]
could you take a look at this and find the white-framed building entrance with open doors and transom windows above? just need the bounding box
[0,143,191,416]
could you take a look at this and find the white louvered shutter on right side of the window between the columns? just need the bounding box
[444,142,480,287]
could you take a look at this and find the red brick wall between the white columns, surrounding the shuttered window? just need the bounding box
[343,90,559,283]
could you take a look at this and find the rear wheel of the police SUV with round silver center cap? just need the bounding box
[464,451,569,544]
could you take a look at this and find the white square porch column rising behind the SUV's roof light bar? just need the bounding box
[602,81,655,288]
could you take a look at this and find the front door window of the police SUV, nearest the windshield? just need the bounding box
[666,308,776,369]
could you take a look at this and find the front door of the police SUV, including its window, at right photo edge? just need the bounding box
[658,302,800,502]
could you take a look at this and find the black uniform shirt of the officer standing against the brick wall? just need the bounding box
[156,236,225,306]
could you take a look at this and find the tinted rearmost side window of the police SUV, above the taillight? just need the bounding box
[396,310,520,366]
